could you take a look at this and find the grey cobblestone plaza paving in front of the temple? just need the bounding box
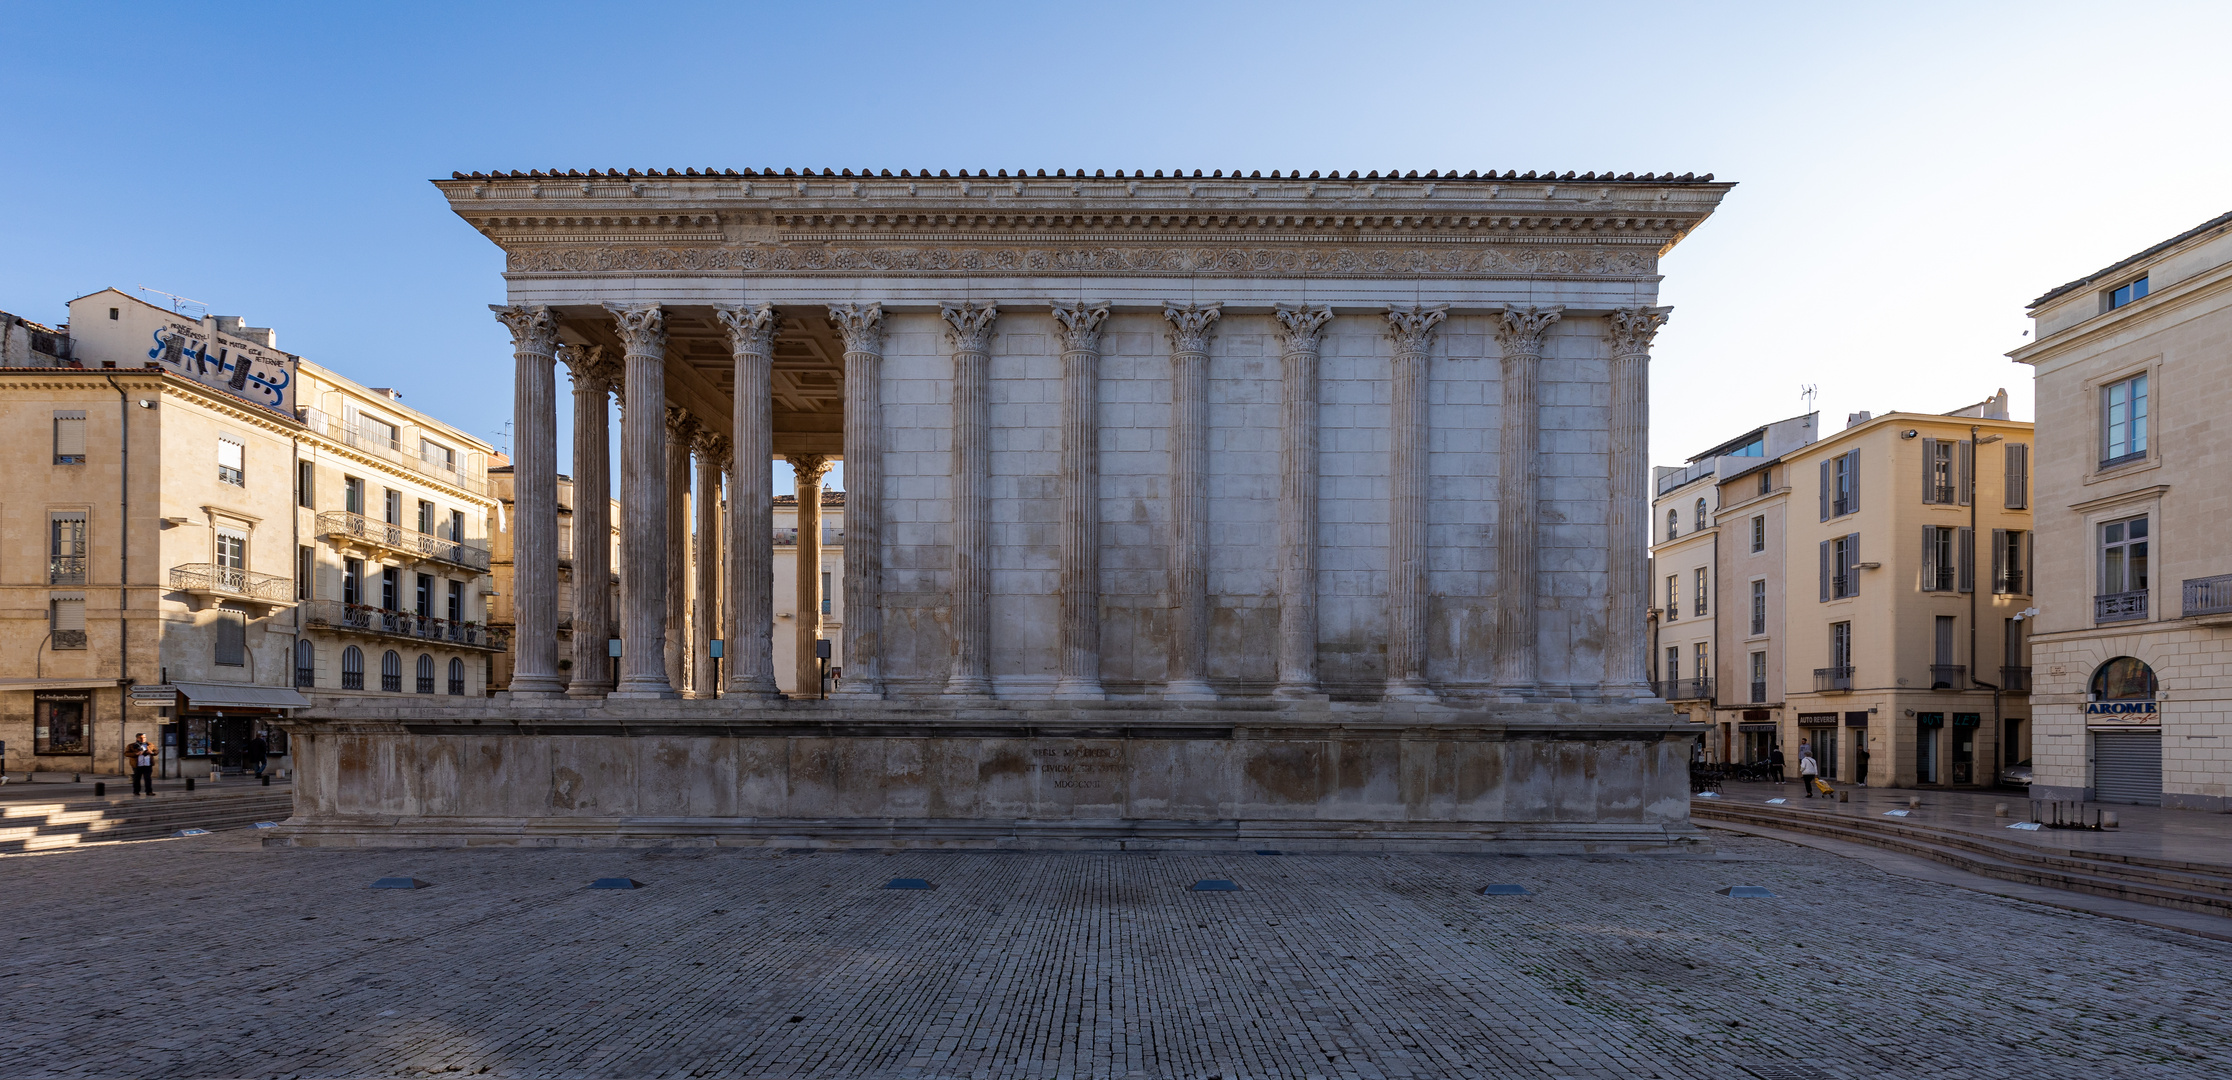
[0,832,2232,1080]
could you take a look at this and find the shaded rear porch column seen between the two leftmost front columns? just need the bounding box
[565,346,614,698]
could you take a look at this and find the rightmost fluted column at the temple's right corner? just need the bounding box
[1605,308,1674,698]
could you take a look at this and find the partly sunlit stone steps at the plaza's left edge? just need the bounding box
[0,783,295,855]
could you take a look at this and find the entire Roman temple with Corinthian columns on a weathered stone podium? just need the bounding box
[281,170,1730,846]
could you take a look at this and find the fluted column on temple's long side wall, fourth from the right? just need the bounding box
[1272,306,1333,698]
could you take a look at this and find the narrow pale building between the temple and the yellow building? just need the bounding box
[1652,413,1819,761]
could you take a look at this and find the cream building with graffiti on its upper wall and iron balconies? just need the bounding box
[0,290,502,777]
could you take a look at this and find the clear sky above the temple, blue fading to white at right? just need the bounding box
[0,0,2232,481]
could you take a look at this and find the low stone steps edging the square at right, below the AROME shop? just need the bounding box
[1690,801,2232,917]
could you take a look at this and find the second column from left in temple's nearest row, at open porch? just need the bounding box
[607,303,676,698]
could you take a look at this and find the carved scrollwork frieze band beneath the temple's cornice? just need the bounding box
[504,243,1658,277]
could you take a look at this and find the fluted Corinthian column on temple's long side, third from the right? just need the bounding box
[1386,306,1449,701]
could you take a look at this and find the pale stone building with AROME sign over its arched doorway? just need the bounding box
[2009,214,2232,812]
